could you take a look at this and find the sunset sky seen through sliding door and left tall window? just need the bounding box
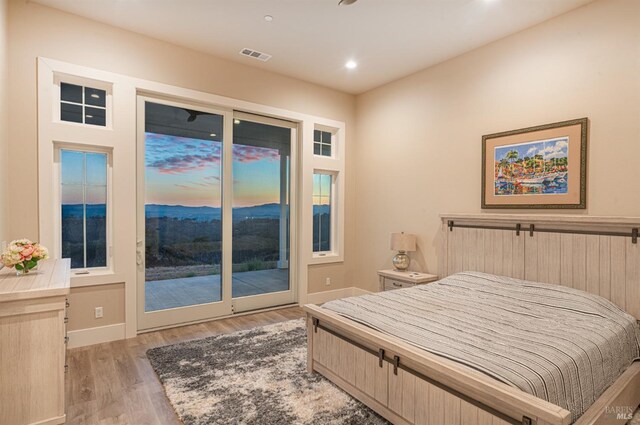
[61,133,280,207]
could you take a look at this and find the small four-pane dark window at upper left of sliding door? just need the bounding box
[60,83,107,127]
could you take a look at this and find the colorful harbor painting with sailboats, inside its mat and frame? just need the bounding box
[494,136,569,196]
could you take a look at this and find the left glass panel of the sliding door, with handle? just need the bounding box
[138,100,231,329]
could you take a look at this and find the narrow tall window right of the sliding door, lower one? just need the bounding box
[313,173,333,252]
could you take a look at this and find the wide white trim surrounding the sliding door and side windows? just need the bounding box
[37,58,346,338]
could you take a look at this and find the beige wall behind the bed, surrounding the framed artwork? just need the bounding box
[352,0,640,289]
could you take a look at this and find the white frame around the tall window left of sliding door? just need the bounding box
[53,141,114,276]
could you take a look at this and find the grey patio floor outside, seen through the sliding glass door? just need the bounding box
[145,269,289,311]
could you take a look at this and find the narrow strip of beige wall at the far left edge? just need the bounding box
[0,0,9,245]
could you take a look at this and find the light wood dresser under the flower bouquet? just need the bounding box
[0,259,70,425]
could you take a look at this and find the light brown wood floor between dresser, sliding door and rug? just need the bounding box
[66,307,303,425]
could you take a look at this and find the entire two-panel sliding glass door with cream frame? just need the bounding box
[137,97,296,330]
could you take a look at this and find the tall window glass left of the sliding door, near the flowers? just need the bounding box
[60,149,108,269]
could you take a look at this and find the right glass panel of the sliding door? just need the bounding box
[232,115,295,311]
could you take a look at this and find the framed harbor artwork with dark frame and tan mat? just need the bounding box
[482,118,588,209]
